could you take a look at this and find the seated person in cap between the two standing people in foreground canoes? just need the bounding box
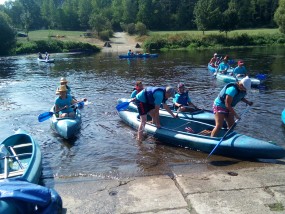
[173,83,198,112]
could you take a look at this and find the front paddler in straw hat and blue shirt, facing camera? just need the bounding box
[54,85,76,118]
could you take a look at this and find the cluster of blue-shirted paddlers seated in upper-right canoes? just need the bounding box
[209,53,248,77]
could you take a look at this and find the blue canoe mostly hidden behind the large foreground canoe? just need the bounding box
[117,98,219,127]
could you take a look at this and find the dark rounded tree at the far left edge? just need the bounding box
[0,11,16,55]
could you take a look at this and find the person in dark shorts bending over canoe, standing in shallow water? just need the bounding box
[133,86,176,141]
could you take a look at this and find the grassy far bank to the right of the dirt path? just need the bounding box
[144,29,285,50]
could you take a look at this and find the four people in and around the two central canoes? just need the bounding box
[130,76,253,141]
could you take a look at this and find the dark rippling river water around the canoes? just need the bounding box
[0,47,285,182]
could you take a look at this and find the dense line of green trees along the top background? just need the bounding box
[0,0,278,31]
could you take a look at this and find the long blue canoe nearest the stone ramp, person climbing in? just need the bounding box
[119,110,285,159]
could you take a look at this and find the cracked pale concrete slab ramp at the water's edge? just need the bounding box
[46,160,285,214]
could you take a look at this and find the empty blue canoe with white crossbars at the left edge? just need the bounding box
[0,130,42,184]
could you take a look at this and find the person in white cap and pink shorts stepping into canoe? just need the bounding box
[211,77,253,137]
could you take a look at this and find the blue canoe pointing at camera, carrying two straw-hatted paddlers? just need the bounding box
[50,108,81,139]
